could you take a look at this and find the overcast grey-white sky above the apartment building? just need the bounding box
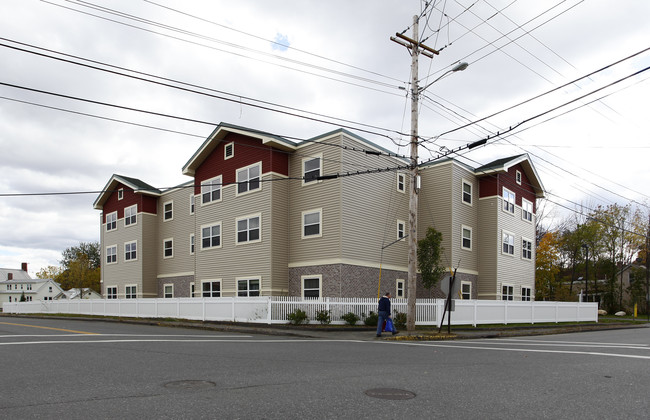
[0,0,650,275]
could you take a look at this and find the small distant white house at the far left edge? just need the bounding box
[0,263,63,303]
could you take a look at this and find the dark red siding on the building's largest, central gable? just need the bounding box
[194,133,289,194]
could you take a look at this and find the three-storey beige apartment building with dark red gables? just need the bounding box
[94,124,543,300]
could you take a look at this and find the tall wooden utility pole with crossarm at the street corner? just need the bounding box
[391,15,438,332]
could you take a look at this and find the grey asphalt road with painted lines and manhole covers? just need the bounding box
[0,317,650,419]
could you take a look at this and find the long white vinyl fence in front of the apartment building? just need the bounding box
[3,296,598,326]
